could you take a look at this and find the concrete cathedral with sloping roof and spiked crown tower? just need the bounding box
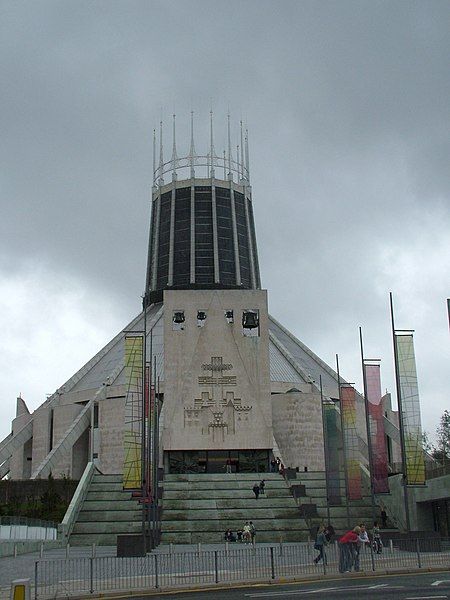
[0,120,412,516]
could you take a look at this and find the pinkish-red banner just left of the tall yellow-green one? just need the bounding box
[364,364,389,494]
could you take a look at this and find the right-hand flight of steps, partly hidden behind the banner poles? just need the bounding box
[290,471,380,533]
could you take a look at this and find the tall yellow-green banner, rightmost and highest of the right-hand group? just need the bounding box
[395,332,425,485]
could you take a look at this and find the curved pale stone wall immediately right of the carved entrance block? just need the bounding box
[272,392,325,471]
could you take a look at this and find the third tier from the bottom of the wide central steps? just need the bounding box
[162,507,300,521]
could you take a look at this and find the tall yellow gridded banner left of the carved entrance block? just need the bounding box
[123,335,144,489]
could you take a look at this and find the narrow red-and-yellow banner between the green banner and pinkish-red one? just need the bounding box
[341,386,362,500]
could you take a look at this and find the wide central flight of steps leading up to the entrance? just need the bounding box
[161,473,309,544]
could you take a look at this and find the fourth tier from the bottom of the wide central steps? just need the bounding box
[162,496,295,511]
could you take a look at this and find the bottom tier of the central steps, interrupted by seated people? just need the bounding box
[161,529,310,548]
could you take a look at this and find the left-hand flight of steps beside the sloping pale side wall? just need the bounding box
[69,473,142,546]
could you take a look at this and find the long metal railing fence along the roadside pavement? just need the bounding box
[34,538,450,600]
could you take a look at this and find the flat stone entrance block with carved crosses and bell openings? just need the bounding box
[162,290,272,450]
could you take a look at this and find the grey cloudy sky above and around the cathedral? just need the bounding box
[0,0,450,438]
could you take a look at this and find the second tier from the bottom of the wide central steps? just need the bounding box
[161,515,307,532]
